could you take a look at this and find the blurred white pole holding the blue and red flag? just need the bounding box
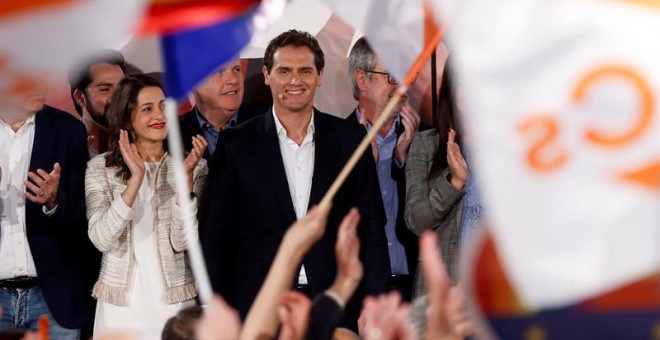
[165,98,213,306]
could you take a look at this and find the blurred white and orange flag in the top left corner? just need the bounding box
[0,0,144,98]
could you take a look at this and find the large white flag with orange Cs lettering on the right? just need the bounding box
[437,0,660,338]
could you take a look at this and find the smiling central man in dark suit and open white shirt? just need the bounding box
[200,30,389,329]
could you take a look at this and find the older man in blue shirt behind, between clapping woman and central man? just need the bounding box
[179,59,262,160]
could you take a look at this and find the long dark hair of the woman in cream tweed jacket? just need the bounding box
[105,74,167,181]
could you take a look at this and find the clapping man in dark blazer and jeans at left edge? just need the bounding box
[0,89,100,339]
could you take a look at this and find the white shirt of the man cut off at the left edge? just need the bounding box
[0,115,37,280]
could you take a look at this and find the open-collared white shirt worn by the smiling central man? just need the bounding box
[273,108,315,284]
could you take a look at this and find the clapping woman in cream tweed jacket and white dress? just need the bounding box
[85,76,208,339]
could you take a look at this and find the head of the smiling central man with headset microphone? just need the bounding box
[263,30,325,112]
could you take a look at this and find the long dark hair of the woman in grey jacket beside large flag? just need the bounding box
[428,59,461,179]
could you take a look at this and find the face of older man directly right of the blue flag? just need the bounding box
[193,59,243,116]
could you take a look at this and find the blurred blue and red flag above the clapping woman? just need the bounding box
[141,0,286,99]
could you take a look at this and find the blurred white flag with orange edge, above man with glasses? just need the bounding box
[323,0,440,80]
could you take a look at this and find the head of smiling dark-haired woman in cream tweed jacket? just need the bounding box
[106,75,167,180]
